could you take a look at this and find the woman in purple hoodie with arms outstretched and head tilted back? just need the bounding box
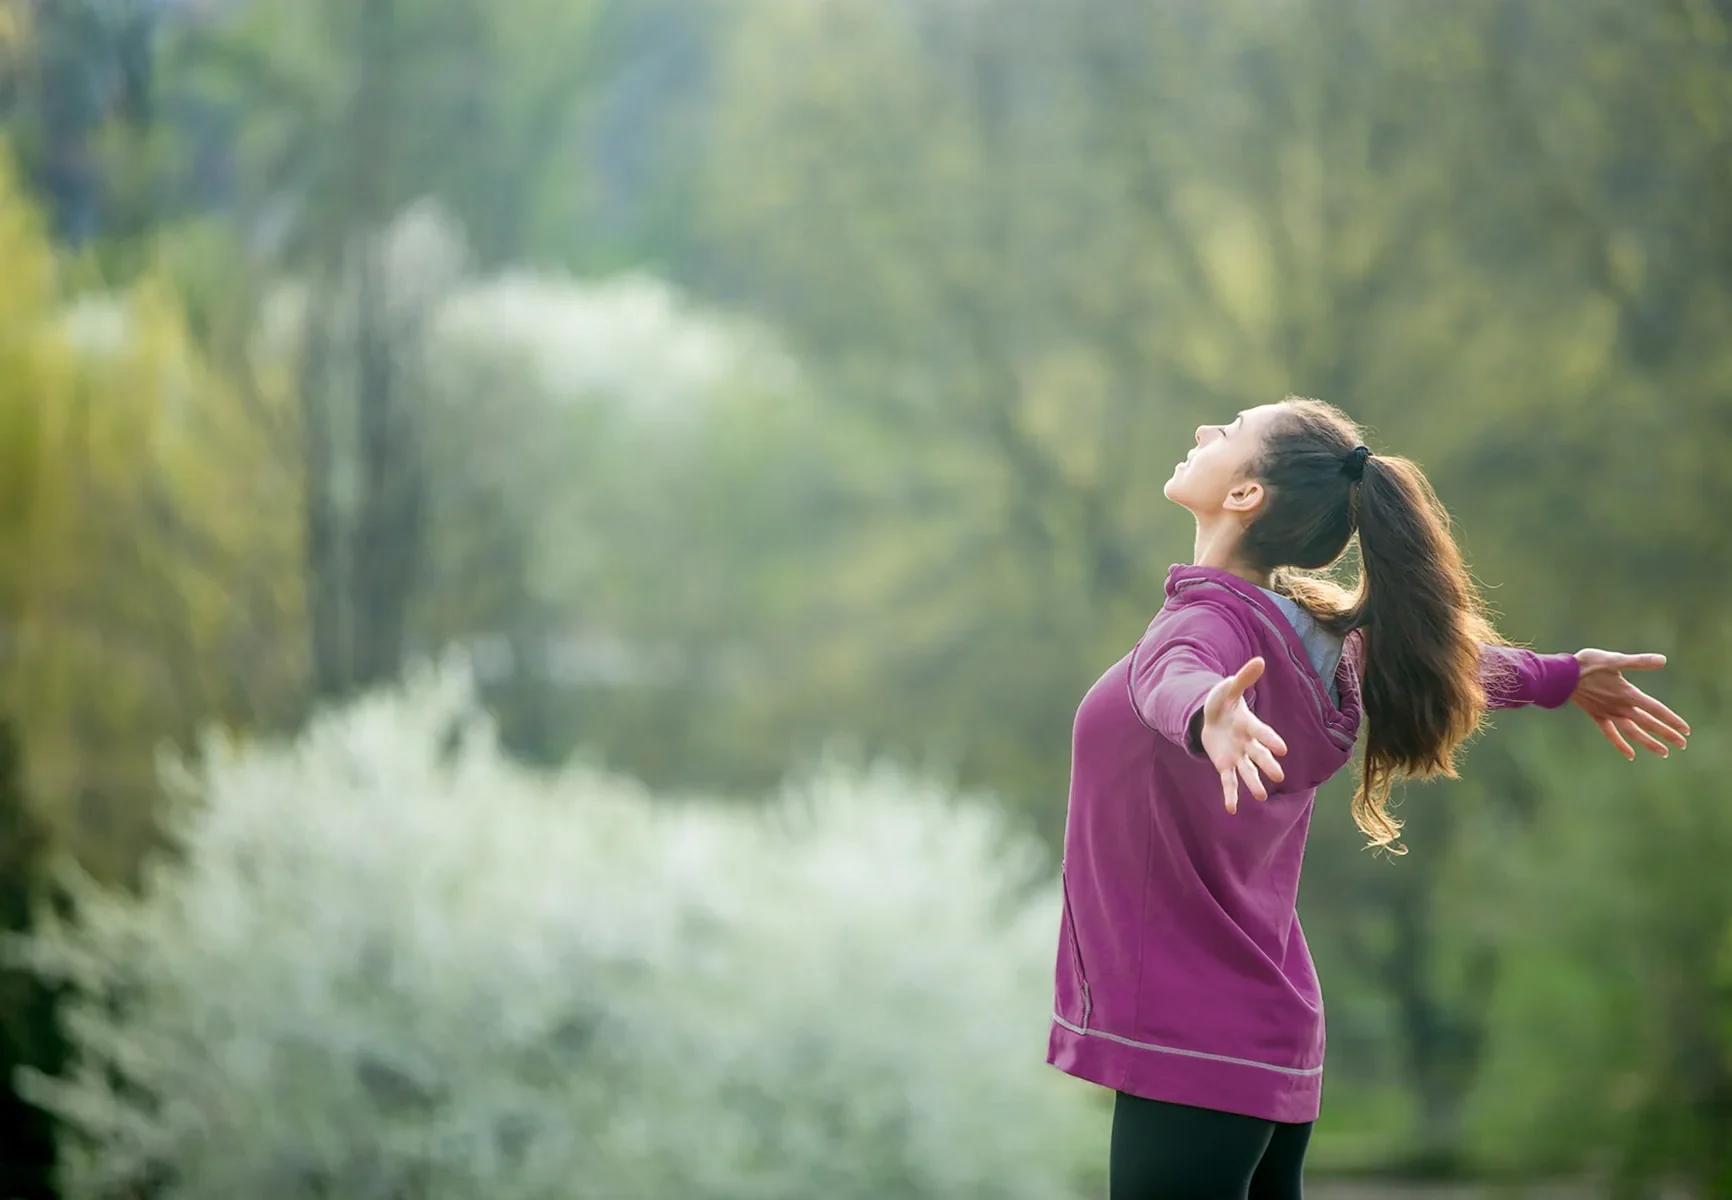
[1048,398,1689,1200]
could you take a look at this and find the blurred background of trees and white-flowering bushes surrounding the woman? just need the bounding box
[0,0,1732,1200]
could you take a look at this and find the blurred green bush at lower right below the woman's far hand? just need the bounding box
[1472,731,1732,1195]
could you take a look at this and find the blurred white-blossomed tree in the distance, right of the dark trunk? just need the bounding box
[405,219,810,635]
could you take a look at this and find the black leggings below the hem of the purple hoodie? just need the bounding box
[1108,1091,1311,1200]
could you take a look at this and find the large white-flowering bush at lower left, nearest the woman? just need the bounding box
[16,672,1095,1200]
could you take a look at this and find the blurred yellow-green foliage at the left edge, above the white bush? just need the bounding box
[9,279,305,874]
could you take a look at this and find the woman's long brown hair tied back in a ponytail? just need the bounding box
[1240,397,1502,854]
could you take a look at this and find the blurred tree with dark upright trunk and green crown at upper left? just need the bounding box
[159,0,602,696]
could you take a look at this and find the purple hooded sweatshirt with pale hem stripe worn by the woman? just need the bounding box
[1046,566,1580,1122]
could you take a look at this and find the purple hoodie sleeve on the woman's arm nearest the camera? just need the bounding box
[1131,603,1256,758]
